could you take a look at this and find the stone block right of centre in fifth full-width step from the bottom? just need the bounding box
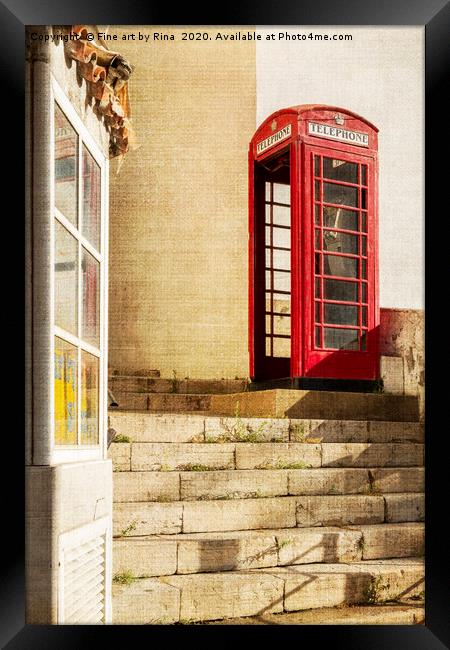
[236,442,321,469]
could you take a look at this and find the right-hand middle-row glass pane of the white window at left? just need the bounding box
[81,248,100,347]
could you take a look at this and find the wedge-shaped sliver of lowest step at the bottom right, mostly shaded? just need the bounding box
[204,599,425,625]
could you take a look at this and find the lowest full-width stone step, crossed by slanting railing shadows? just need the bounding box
[113,558,424,625]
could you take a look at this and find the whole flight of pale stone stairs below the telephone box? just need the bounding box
[109,391,424,624]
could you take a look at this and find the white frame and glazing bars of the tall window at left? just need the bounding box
[49,76,109,465]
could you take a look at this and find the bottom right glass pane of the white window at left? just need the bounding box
[81,350,99,445]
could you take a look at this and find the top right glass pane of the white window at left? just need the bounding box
[82,145,101,250]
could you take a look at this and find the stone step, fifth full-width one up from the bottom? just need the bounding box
[108,442,424,472]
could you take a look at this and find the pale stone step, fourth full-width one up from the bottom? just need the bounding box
[113,467,425,503]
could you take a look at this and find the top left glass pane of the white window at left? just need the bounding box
[55,104,78,226]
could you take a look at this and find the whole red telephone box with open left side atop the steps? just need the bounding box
[249,105,379,385]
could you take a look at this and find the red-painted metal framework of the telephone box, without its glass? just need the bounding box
[249,105,379,379]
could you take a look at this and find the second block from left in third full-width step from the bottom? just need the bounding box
[181,497,298,533]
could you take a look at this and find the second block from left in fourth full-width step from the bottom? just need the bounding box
[180,470,288,501]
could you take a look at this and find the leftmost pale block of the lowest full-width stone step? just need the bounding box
[112,578,180,625]
